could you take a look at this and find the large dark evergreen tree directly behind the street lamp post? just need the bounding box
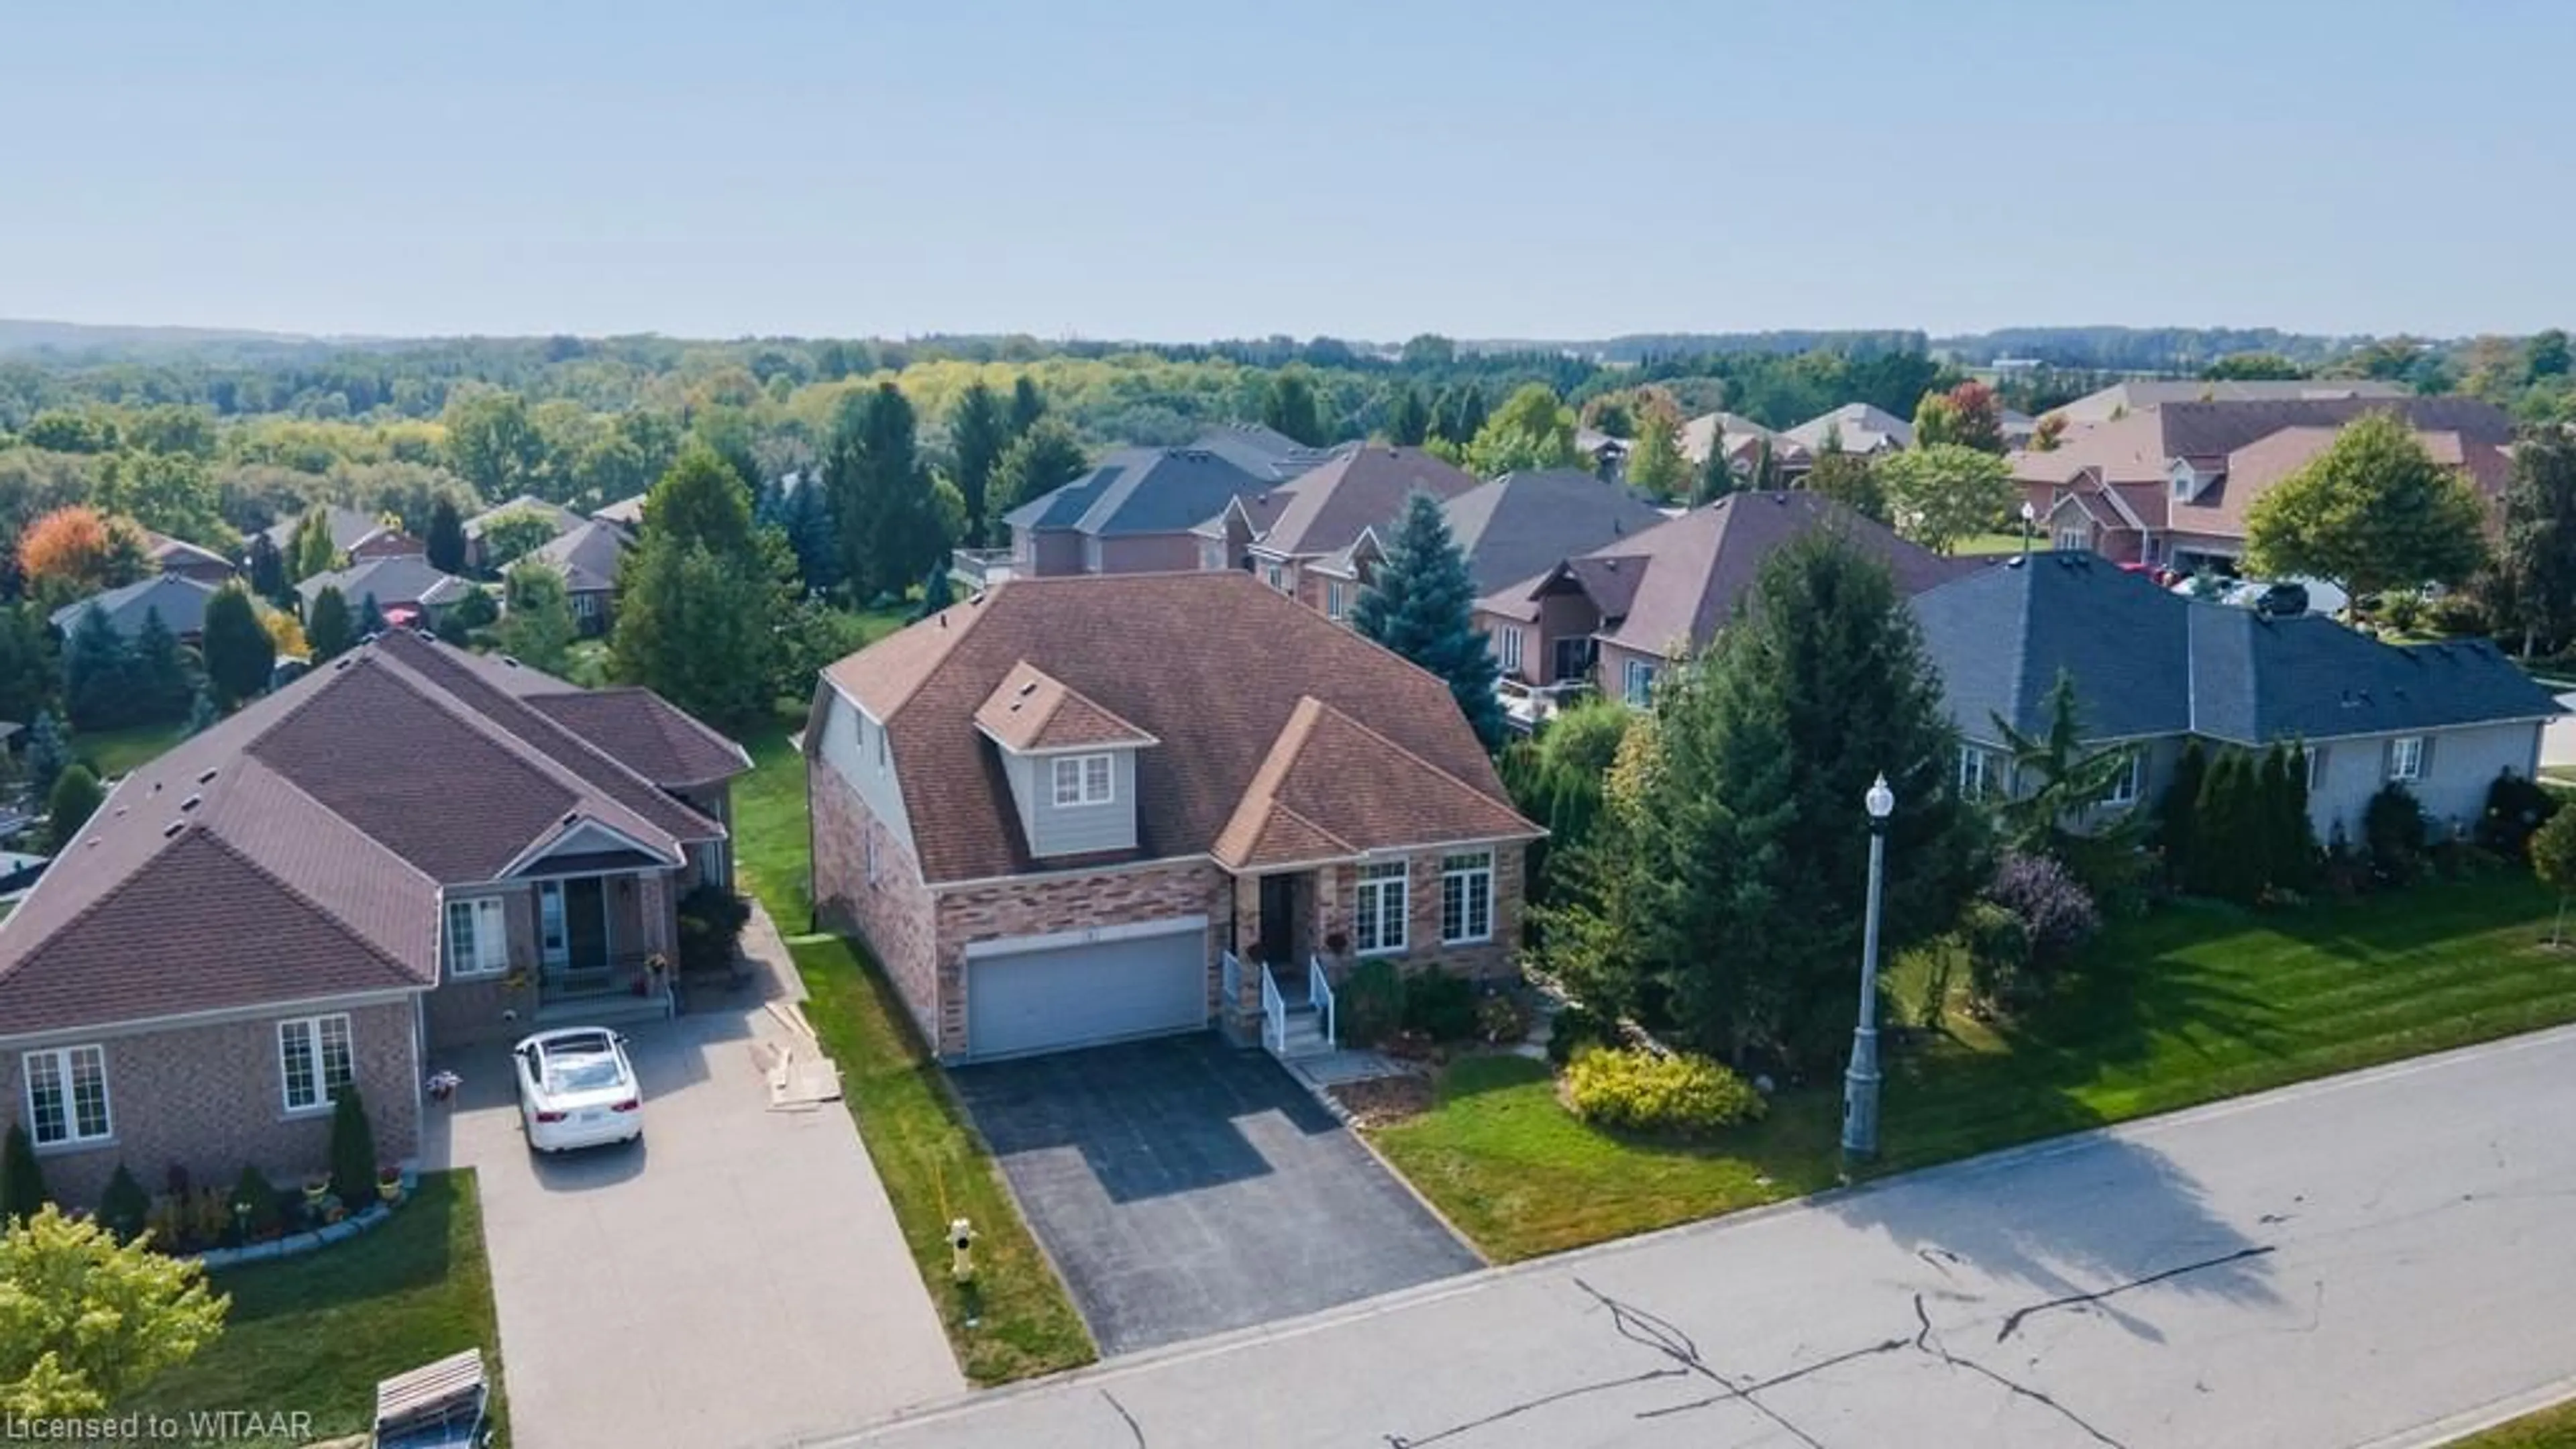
[1625,531,1986,1070]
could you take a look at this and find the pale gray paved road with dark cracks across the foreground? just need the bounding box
[835,1031,2576,1449]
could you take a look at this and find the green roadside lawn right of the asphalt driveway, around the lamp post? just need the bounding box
[1376,874,2576,1260]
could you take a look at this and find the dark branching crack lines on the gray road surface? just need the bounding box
[1381,1243,2275,1449]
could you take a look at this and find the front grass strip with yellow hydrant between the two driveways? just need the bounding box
[788,936,1097,1385]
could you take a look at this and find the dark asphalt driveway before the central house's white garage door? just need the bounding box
[953,1034,1476,1354]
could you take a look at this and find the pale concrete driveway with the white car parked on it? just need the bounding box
[425,922,966,1449]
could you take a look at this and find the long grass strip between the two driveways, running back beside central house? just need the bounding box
[734,712,1095,1385]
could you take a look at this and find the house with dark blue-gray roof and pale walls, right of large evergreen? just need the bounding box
[1914,551,2561,841]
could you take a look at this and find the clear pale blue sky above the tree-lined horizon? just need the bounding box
[0,0,2576,340]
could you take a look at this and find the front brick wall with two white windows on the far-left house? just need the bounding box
[0,1000,420,1210]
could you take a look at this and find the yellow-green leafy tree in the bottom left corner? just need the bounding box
[0,1204,232,1424]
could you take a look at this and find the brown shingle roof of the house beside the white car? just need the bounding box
[0,632,721,1036]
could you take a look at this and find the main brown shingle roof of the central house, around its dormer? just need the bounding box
[809,570,1538,881]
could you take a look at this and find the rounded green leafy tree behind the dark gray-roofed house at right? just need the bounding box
[2246,413,2486,598]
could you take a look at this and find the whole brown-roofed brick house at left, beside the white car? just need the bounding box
[0,632,749,1207]
